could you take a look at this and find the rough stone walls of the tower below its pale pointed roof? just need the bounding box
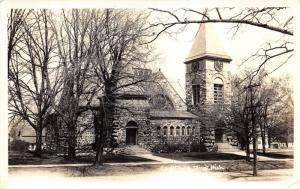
[186,59,231,151]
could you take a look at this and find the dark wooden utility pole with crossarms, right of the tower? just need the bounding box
[244,81,261,176]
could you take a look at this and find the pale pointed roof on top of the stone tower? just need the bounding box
[185,23,231,63]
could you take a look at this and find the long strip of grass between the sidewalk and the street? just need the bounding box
[9,161,293,177]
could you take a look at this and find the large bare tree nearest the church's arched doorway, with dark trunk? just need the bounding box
[88,9,154,164]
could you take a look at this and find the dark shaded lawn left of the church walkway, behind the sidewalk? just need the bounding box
[8,152,154,165]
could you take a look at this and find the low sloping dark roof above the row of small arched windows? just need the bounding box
[150,110,199,119]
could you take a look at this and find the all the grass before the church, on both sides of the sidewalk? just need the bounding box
[9,152,293,177]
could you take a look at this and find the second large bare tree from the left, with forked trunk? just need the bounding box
[47,9,96,158]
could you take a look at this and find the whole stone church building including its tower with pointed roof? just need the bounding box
[46,24,237,152]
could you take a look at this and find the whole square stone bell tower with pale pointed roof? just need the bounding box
[184,23,231,148]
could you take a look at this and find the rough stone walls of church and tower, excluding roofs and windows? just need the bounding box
[46,60,230,153]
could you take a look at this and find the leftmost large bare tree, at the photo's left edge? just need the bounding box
[8,10,59,151]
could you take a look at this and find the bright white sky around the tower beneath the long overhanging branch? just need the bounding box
[156,23,293,87]
